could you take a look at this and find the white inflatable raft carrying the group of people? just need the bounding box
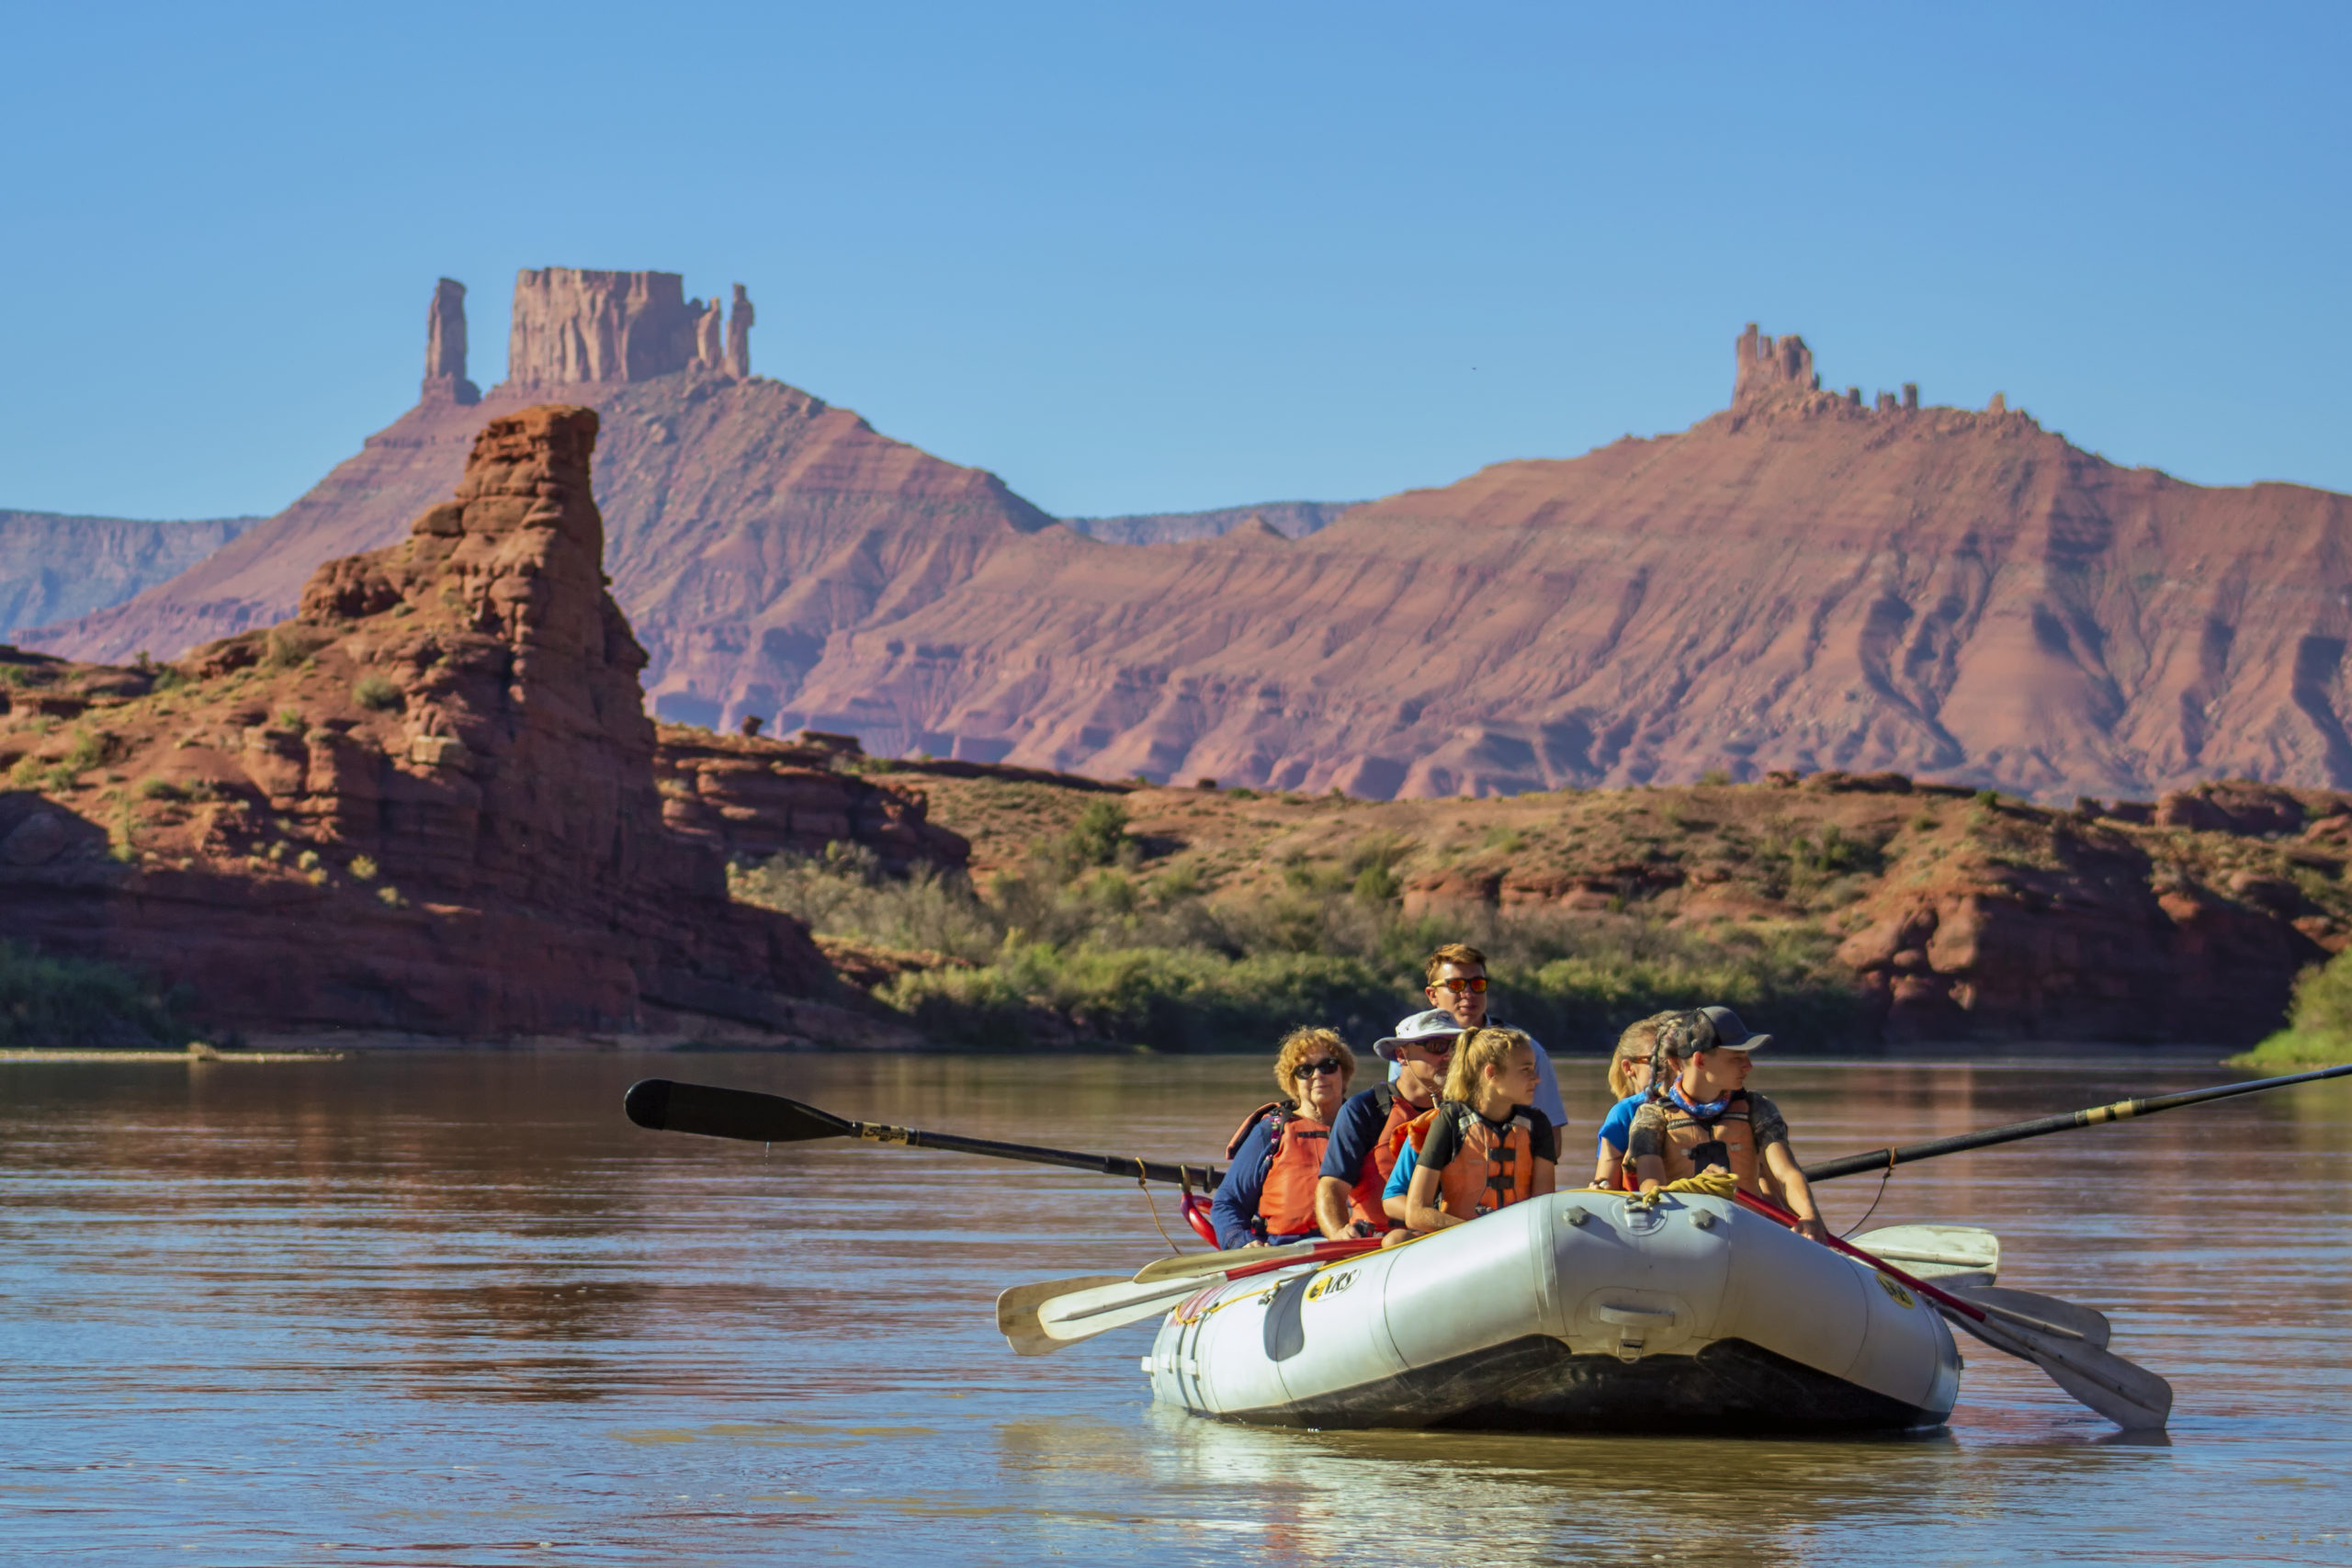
[1143,1192,1959,1432]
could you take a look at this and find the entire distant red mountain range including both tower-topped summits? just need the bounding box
[28,290,2352,802]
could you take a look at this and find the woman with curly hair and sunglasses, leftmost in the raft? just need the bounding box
[1209,1030,1355,1246]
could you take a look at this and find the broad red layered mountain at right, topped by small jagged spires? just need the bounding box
[786,336,2352,802]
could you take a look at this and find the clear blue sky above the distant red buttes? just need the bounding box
[0,0,2352,517]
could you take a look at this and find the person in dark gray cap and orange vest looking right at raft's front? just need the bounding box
[1625,1006,1823,1241]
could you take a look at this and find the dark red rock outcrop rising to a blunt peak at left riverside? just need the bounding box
[0,407,917,1039]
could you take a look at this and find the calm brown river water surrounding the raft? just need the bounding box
[0,1054,2352,1565]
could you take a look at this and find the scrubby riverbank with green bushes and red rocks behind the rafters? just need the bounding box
[734,760,2352,1054]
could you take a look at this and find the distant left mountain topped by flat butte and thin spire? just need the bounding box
[24,268,1054,727]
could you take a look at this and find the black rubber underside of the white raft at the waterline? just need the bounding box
[1227,1335,1940,1437]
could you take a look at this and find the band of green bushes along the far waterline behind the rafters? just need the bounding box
[736,822,1856,1054]
